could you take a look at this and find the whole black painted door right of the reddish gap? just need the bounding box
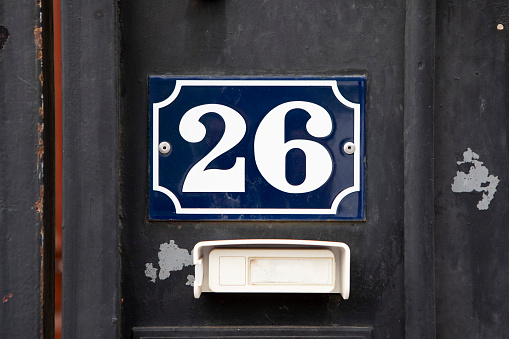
[63,0,509,338]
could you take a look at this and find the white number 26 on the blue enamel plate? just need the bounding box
[179,101,333,193]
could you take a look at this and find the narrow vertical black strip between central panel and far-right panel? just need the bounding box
[403,0,435,339]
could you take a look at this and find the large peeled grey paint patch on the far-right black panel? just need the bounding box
[451,148,500,210]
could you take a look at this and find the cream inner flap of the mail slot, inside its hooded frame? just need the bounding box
[208,248,335,293]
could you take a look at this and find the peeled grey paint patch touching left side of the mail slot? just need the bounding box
[145,240,194,286]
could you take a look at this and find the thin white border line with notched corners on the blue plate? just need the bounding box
[152,80,361,214]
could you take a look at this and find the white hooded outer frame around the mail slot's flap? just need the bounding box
[193,239,350,299]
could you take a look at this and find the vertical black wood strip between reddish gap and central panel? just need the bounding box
[62,0,120,338]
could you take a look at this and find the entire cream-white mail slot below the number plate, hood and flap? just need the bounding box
[193,239,350,299]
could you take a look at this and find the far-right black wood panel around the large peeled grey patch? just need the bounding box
[435,0,509,338]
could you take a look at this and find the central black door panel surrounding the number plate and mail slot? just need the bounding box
[120,0,405,338]
